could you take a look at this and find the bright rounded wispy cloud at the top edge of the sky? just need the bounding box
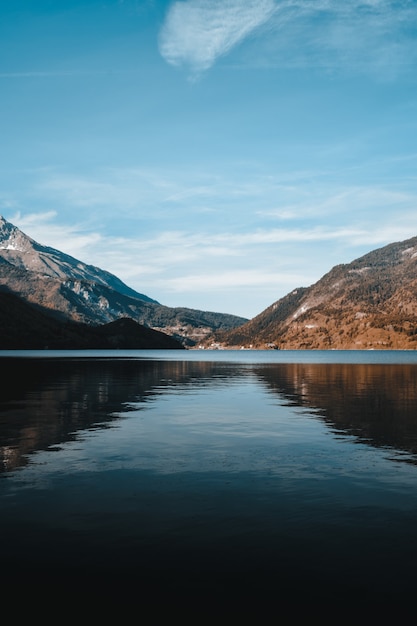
[159,0,276,73]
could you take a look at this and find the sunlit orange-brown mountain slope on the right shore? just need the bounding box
[212,237,417,349]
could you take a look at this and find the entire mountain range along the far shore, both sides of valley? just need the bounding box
[0,217,417,349]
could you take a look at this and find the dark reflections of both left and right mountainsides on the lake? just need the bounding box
[0,359,417,471]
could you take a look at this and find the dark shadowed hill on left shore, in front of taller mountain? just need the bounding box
[0,291,184,350]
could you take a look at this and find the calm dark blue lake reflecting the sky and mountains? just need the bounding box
[0,351,417,623]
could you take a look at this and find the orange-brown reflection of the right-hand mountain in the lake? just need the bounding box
[254,363,417,463]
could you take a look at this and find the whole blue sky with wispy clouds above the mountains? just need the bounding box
[0,0,417,317]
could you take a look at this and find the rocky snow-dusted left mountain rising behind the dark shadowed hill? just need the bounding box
[0,216,247,345]
